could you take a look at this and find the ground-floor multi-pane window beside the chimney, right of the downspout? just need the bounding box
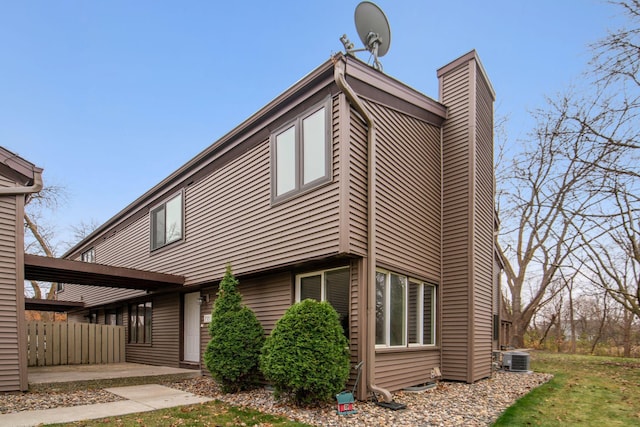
[376,270,436,347]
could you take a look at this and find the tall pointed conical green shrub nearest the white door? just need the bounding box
[204,265,264,393]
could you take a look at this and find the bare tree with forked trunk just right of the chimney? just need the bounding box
[496,94,615,347]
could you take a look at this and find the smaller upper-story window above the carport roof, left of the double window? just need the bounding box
[151,192,184,250]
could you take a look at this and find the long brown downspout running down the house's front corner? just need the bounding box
[333,54,393,402]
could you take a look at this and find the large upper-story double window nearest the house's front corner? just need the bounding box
[271,101,331,200]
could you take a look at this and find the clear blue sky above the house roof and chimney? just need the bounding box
[0,0,624,253]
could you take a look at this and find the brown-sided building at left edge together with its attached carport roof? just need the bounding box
[0,147,185,392]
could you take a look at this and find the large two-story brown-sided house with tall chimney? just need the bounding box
[59,51,499,398]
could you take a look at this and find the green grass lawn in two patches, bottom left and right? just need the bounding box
[45,352,640,427]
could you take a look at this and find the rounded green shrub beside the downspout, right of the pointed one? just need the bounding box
[260,299,349,405]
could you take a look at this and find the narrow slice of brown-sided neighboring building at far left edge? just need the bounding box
[0,147,42,391]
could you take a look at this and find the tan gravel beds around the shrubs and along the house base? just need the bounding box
[0,372,552,426]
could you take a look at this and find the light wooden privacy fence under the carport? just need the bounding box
[27,322,125,366]
